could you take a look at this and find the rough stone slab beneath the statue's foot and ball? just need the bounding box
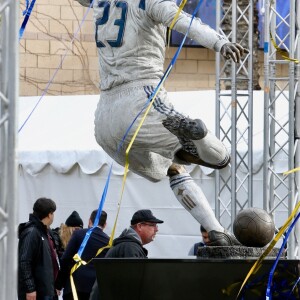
[197,246,284,259]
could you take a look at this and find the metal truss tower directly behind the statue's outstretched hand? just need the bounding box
[215,0,254,229]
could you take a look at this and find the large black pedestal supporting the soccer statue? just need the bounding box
[93,258,300,300]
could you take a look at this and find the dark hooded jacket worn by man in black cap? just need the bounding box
[105,227,148,258]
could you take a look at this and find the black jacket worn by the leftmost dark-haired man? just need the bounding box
[18,214,55,299]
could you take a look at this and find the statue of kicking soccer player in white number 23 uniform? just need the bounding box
[77,0,246,246]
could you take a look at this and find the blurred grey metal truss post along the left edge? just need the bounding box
[0,0,19,299]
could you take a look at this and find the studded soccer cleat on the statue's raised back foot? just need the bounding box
[162,116,207,140]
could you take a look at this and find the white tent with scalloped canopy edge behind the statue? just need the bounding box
[18,91,286,257]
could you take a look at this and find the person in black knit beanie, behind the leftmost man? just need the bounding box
[52,210,83,258]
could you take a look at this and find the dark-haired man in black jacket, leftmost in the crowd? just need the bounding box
[18,198,59,300]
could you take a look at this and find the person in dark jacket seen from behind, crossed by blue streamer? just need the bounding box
[55,210,109,300]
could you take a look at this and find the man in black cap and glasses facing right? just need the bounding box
[90,209,164,300]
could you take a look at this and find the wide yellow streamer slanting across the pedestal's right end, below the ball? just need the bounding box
[236,202,300,299]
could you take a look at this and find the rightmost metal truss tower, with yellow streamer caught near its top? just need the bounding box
[264,0,300,258]
